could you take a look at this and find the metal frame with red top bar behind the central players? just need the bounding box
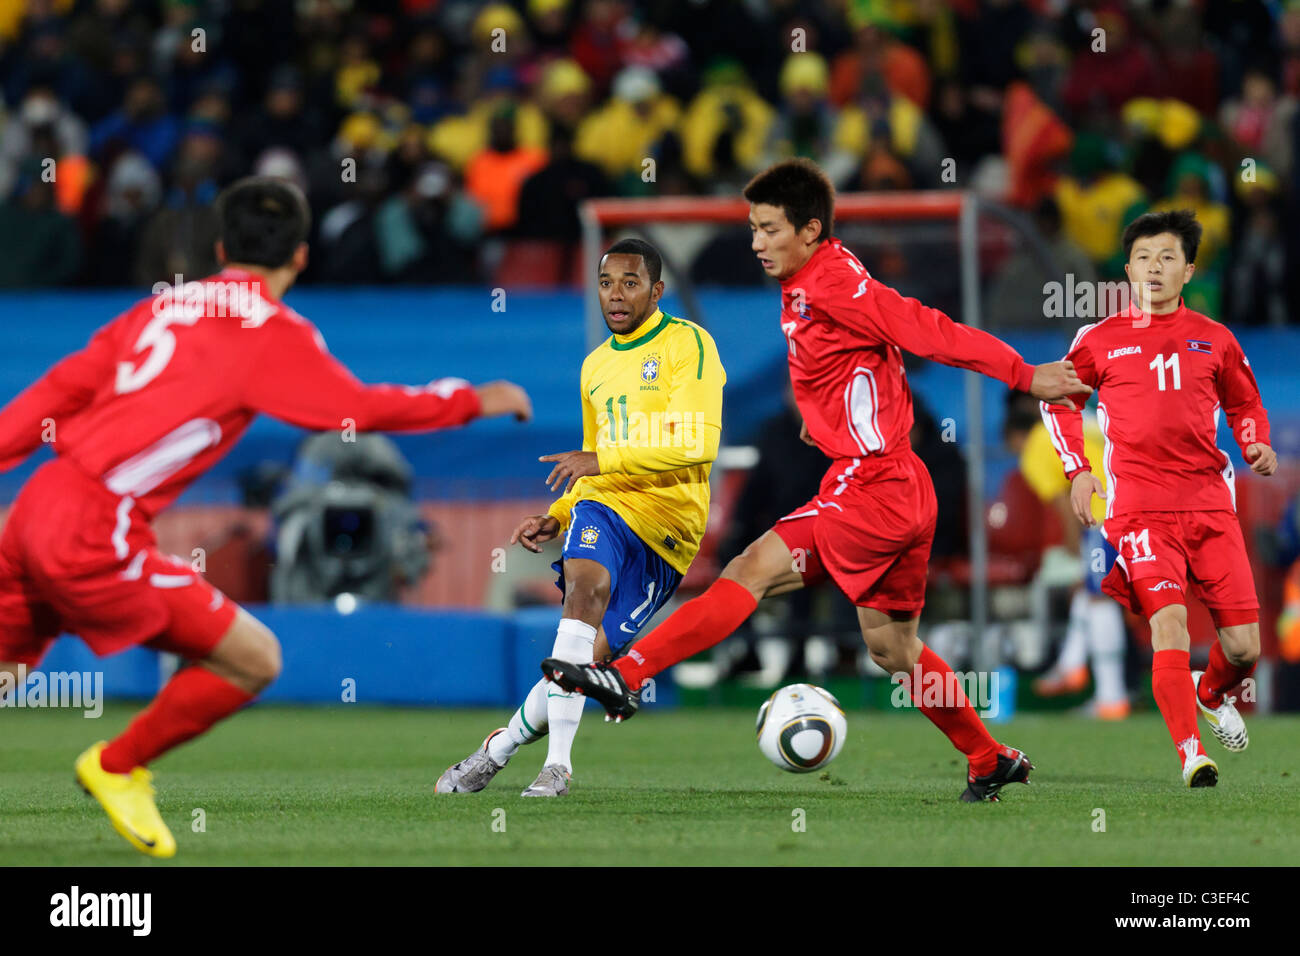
[579,190,993,660]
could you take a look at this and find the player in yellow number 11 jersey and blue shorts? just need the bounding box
[434,239,727,796]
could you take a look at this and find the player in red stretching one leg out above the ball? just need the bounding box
[542,160,1091,801]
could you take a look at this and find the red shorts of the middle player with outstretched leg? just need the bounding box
[772,449,939,615]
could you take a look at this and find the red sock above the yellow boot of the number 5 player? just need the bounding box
[100,666,254,774]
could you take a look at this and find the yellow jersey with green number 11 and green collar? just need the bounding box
[550,311,727,574]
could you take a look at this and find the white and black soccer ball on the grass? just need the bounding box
[754,684,849,774]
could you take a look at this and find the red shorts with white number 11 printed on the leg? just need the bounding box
[1101,511,1260,627]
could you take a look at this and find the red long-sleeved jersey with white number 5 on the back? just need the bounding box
[0,269,480,518]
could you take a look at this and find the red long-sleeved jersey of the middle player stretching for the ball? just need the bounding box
[781,238,1034,475]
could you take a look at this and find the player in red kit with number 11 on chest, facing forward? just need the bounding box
[1043,209,1278,787]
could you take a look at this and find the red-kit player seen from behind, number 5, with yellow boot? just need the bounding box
[0,178,532,856]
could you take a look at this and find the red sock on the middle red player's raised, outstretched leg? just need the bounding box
[614,578,758,691]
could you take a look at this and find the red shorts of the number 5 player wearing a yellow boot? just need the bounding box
[0,459,237,667]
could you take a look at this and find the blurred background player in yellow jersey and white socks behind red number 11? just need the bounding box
[1021,392,1130,721]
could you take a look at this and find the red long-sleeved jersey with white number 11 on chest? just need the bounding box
[1043,303,1269,518]
